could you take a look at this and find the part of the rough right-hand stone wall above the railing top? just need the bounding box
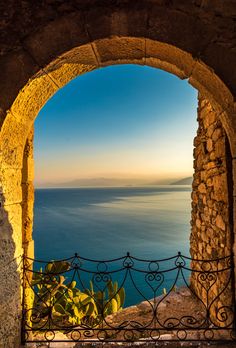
[190,97,233,259]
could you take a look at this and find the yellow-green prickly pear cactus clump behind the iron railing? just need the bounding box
[32,261,125,325]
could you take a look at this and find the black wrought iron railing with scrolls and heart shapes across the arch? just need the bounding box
[22,253,236,343]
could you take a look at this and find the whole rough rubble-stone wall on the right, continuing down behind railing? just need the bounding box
[190,96,233,325]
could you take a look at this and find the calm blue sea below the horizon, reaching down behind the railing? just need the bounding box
[33,185,191,306]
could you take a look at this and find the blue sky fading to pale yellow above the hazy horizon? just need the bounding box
[34,65,197,186]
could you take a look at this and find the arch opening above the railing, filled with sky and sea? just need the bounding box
[34,65,197,259]
